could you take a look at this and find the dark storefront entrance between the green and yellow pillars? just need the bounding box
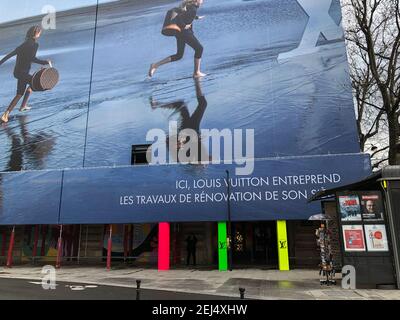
[232,221,278,268]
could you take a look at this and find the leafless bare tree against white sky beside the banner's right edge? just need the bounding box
[342,0,400,167]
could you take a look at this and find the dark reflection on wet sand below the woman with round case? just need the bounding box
[3,115,55,171]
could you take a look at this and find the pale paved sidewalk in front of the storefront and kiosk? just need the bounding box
[0,266,400,300]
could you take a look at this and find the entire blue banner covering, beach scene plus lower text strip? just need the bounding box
[0,0,370,224]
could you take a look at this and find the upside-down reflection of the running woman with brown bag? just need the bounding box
[150,79,211,164]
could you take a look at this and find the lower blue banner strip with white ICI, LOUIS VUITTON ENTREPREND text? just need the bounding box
[0,154,371,224]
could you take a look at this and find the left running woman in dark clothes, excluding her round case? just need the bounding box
[0,26,51,123]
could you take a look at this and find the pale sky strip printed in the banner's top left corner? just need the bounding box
[0,0,115,23]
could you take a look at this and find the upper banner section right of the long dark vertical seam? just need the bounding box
[85,0,358,170]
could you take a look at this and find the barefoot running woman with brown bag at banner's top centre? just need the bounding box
[149,0,206,78]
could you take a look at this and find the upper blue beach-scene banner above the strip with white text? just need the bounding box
[0,0,359,171]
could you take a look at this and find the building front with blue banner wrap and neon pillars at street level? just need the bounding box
[0,0,371,270]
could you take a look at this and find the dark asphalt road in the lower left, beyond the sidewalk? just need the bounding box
[0,278,238,300]
